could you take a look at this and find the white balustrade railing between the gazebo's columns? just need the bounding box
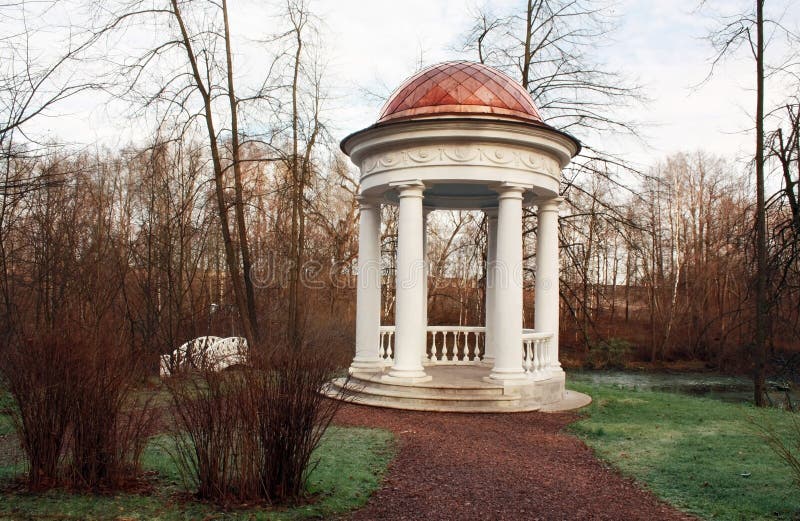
[378,326,553,376]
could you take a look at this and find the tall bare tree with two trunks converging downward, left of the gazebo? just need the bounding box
[99,0,294,342]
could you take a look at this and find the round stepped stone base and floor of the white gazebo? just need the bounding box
[327,365,591,413]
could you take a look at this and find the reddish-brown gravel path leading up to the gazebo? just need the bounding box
[335,405,693,521]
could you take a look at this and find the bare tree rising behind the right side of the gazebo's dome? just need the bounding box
[462,0,642,350]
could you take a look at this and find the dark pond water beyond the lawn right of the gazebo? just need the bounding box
[567,370,800,407]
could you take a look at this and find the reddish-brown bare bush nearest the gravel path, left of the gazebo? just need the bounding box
[167,343,340,504]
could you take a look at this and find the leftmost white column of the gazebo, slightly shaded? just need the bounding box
[350,197,383,372]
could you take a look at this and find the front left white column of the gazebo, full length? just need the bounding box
[384,181,430,381]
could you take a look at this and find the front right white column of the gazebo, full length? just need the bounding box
[489,184,527,383]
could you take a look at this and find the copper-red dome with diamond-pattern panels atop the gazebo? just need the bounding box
[378,61,542,123]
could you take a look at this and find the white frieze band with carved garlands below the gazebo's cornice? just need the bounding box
[361,145,561,179]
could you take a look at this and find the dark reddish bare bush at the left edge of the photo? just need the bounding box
[0,332,154,490]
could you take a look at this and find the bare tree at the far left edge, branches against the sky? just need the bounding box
[0,0,106,332]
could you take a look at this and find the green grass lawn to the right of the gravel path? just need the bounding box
[570,383,800,520]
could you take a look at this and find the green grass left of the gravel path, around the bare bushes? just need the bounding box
[0,427,394,521]
